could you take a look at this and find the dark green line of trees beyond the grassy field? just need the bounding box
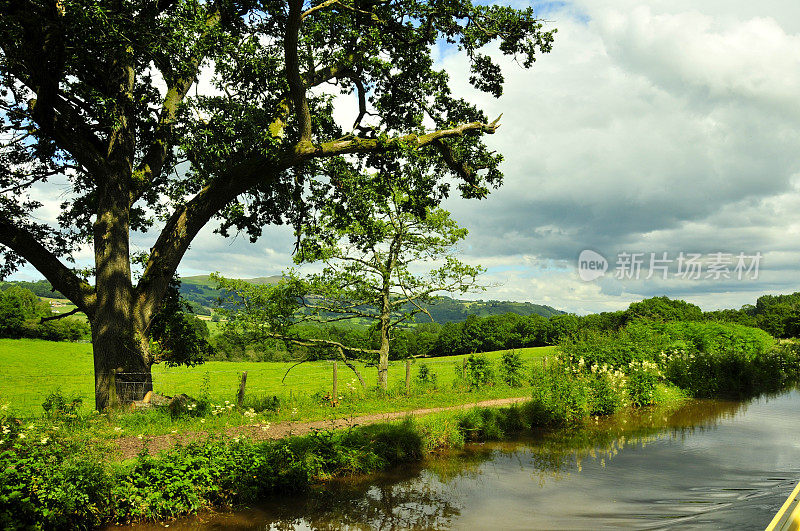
[0,281,800,360]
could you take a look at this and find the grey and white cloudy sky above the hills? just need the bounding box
[9,0,800,313]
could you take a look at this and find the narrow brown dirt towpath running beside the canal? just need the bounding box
[116,396,530,459]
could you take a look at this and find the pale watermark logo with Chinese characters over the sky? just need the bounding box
[578,249,762,282]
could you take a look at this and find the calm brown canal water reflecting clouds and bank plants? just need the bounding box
[142,390,800,530]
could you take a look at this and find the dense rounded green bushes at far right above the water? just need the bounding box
[560,321,800,405]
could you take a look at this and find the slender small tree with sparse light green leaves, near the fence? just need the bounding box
[218,175,483,389]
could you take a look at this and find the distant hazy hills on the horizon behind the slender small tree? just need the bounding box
[181,275,564,324]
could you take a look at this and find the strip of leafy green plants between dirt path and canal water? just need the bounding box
[0,401,688,529]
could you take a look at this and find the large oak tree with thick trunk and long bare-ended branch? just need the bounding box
[0,0,553,409]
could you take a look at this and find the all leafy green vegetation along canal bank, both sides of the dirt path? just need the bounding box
[0,321,800,528]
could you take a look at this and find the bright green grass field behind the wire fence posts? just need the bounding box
[0,339,554,415]
